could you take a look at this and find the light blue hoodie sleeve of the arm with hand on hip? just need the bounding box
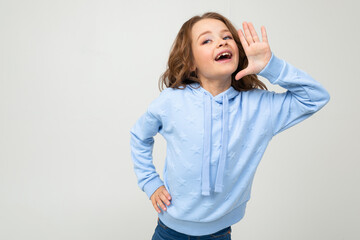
[130,95,164,198]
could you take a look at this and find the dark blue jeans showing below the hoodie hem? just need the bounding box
[151,219,231,240]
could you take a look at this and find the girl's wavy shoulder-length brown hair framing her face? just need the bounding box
[159,12,267,91]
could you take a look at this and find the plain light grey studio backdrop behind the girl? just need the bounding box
[0,0,360,240]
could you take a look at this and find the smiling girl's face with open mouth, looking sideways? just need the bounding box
[191,19,239,81]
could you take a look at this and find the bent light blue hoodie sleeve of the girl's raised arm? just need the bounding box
[259,54,330,135]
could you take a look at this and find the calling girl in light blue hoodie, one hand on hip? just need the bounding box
[131,13,329,240]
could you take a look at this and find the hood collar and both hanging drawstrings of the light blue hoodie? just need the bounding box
[188,83,239,196]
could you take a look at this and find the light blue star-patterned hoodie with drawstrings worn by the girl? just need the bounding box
[131,55,329,236]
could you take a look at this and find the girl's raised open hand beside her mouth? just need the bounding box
[235,22,271,80]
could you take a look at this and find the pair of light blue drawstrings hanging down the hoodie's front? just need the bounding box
[201,93,229,196]
